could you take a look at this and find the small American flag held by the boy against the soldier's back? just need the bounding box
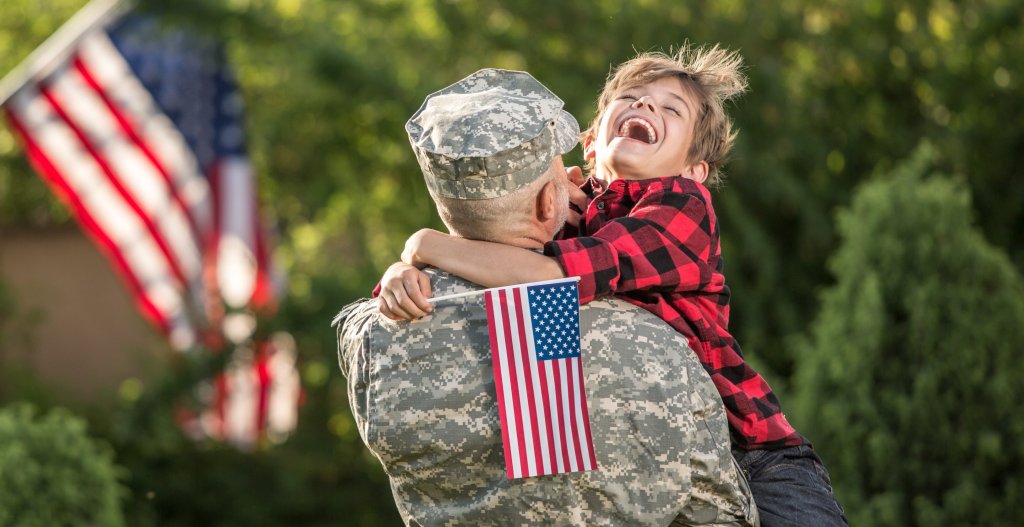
[485,277,597,479]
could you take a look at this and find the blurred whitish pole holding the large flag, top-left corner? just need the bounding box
[0,0,133,106]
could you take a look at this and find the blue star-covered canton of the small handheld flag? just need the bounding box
[526,282,580,360]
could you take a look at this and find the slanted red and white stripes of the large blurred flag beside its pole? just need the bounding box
[6,32,218,349]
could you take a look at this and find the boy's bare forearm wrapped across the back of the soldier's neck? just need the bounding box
[401,229,565,288]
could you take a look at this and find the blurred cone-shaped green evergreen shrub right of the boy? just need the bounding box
[791,145,1024,527]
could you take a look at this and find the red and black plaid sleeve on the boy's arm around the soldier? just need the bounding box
[544,189,714,303]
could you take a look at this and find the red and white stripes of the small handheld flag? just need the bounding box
[485,281,597,479]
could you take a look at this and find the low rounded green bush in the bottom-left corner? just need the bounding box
[0,405,124,527]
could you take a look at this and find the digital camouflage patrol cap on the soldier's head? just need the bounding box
[406,69,580,200]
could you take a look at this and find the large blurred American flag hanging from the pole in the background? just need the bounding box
[0,0,298,443]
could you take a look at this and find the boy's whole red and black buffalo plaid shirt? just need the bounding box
[544,176,806,450]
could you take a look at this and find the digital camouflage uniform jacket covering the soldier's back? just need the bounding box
[338,269,757,526]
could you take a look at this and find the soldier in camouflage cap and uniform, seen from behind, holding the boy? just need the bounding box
[336,70,758,526]
